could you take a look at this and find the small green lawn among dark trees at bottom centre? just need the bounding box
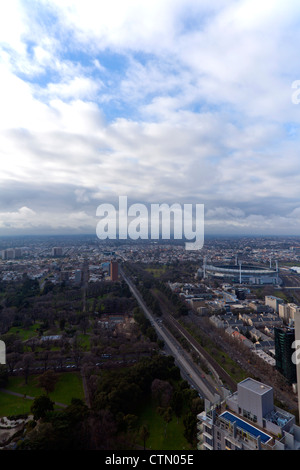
[138,402,191,450]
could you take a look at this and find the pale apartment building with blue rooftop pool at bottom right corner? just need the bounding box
[197,378,300,450]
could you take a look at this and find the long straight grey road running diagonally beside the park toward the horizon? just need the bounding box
[119,266,220,402]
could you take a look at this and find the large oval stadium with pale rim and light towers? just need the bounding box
[198,260,281,285]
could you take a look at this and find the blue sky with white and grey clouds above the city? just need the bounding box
[0,0,300,236]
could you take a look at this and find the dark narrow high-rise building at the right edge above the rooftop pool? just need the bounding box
[274,327,297,384]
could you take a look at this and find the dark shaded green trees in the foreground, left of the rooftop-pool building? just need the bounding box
[17,355,203,450]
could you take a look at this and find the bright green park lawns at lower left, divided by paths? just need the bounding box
[0,372,84,416]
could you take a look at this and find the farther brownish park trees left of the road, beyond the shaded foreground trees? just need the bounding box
[0,276,158,376]
